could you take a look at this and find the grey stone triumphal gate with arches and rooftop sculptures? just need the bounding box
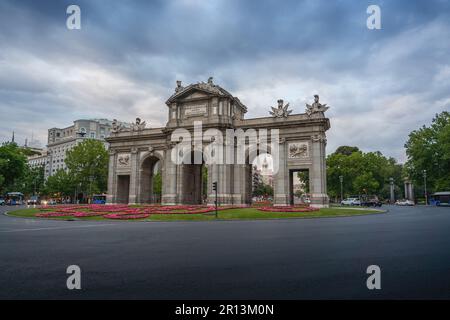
[107,78,330,207]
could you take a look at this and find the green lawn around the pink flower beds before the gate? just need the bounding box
[9,208,383,221]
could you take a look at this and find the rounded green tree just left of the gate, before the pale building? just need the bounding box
[65,139,109,195]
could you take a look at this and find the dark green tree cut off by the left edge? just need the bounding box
[0,142,27,192]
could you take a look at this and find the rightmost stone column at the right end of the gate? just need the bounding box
[309,133,329,208]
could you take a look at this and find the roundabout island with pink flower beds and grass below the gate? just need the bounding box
[8,204,385,221]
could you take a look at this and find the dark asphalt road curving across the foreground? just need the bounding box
[0,207,450,299]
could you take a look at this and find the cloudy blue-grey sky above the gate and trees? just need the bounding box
[0,0,450,162]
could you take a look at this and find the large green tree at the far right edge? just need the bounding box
[405,111,450,192]
